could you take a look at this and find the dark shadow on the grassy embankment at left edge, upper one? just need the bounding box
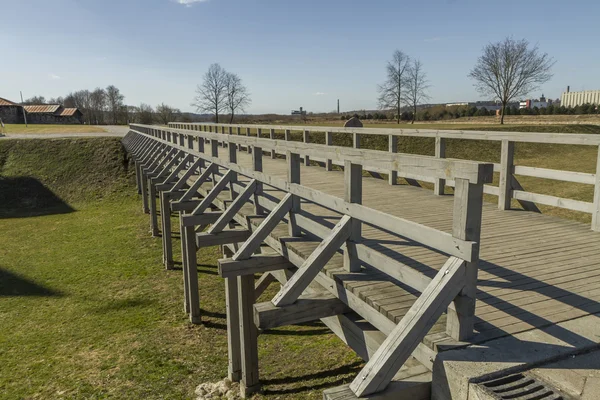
[0,176,75,219]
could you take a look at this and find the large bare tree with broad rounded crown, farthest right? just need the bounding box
[469,38,554,124]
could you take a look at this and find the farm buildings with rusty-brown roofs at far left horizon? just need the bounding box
[0,98,83,124]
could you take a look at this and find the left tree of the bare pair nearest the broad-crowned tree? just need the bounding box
[378,50,410,123]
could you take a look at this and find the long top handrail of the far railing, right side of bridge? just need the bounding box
[169,122,600,146]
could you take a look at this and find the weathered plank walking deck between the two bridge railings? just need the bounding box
[231,152,600,343]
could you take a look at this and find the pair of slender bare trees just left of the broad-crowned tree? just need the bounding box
[378,50,429,123]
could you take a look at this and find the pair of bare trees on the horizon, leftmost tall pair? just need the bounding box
[192,64,251,123]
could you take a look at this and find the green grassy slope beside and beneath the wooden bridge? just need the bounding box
[0,139,360,399]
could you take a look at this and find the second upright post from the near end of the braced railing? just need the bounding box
[344,161,362,272]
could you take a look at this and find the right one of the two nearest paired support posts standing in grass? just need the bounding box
[237,275,260,398]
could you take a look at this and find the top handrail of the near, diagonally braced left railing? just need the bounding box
[130,124,493,183]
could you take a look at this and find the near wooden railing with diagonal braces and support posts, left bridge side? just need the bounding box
[123,125,493,396]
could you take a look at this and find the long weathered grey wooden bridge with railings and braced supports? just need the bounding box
[123,124,600,399]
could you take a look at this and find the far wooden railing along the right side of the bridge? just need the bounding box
[169,122,600,231]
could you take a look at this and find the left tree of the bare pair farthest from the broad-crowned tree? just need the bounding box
[192,64,228,123]
